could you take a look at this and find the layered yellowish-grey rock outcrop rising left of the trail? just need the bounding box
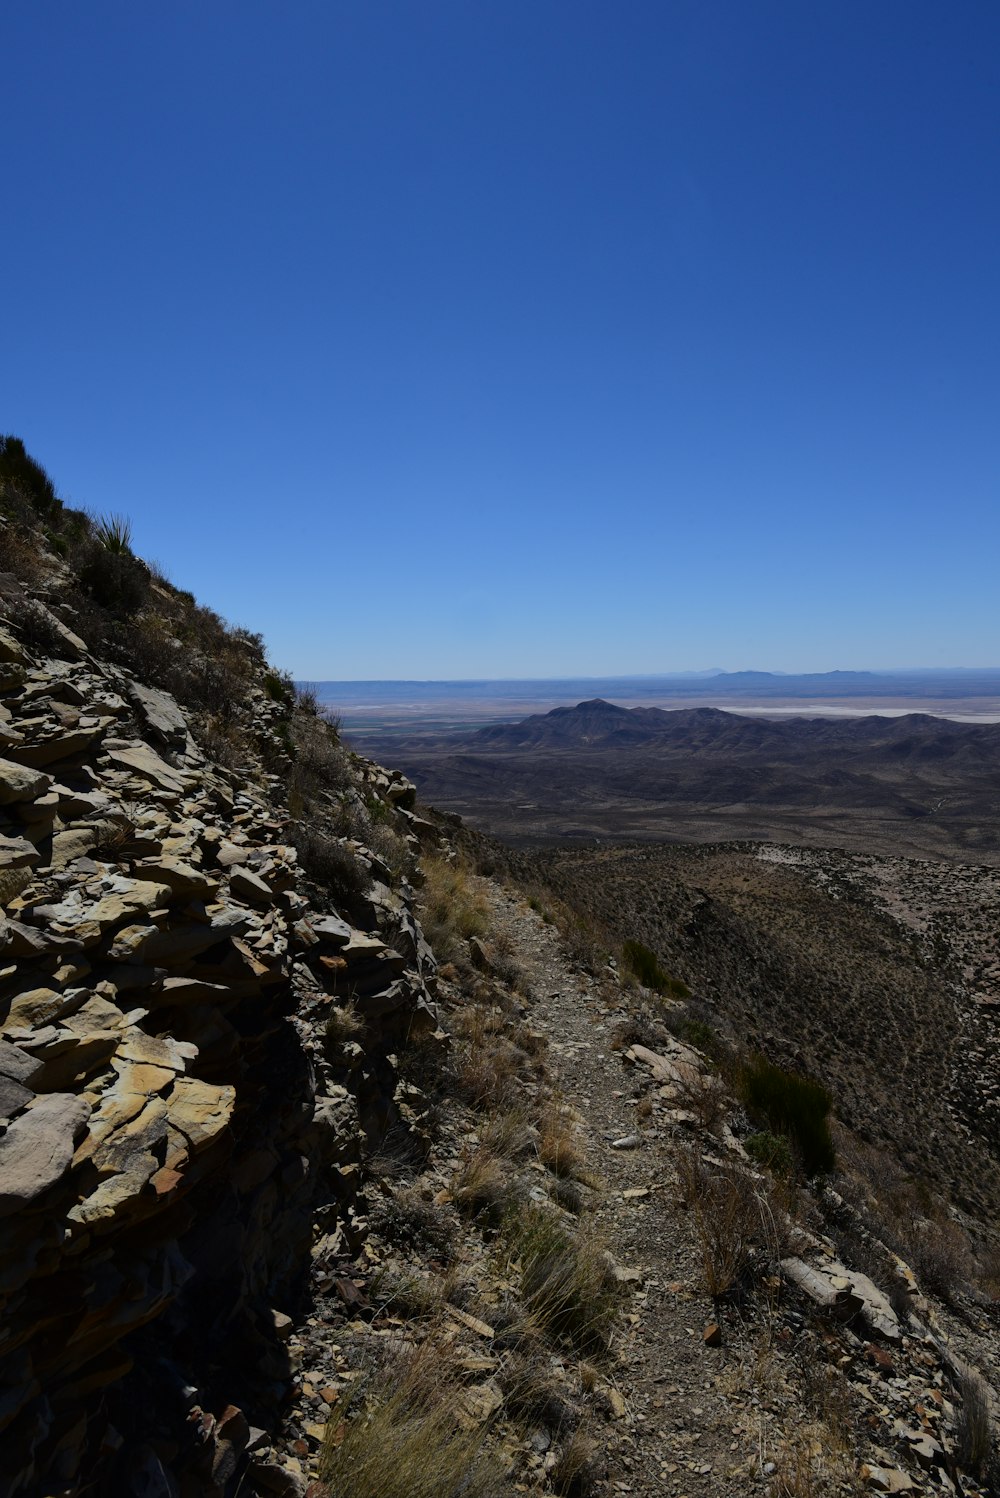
[0,590,436,1495]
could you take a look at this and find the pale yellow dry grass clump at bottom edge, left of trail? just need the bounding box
[319,1339,509,1498]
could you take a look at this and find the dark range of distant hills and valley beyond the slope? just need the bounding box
[371,700,1000,861]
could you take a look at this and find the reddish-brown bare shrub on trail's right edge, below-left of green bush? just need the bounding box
[678,1147,778,1299]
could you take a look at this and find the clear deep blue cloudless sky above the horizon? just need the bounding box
[0,0,1000,679]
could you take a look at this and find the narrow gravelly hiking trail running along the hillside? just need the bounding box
[485,884,790,1495]
